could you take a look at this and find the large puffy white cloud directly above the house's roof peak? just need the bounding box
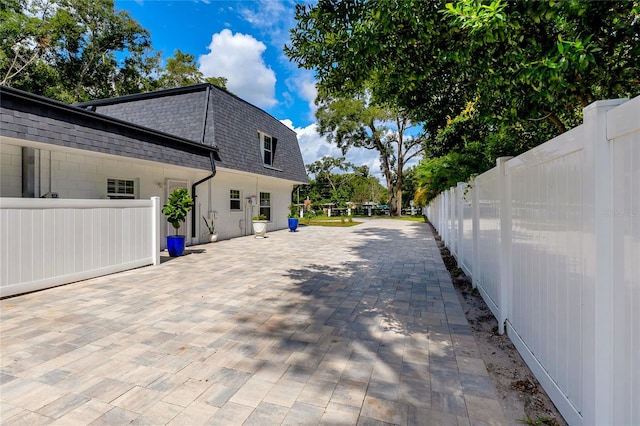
[199,29,277,108]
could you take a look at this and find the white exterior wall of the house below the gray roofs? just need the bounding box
[0,139,300,249]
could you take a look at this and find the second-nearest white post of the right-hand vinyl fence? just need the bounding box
[496,157,513,335]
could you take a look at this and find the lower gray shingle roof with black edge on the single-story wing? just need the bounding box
[0,86,216,170]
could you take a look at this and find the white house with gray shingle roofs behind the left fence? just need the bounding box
[0,84,307,243]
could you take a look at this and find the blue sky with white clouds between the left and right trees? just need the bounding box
[115,0,379,176]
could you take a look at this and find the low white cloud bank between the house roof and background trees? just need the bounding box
[281,119,383,179]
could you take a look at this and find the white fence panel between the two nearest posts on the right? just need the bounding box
[506,126,594,422]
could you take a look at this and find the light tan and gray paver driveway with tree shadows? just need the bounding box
[0,220,505,425]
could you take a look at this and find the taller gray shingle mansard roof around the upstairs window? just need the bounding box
[78,84,307,183]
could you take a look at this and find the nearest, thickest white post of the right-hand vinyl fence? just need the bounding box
[582,99,625,424]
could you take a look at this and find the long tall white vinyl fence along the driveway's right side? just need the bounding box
[425,97,640,425]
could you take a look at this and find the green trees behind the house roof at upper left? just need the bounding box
[0,0,226,103]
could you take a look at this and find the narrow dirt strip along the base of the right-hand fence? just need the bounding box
[432,227,567,426]
